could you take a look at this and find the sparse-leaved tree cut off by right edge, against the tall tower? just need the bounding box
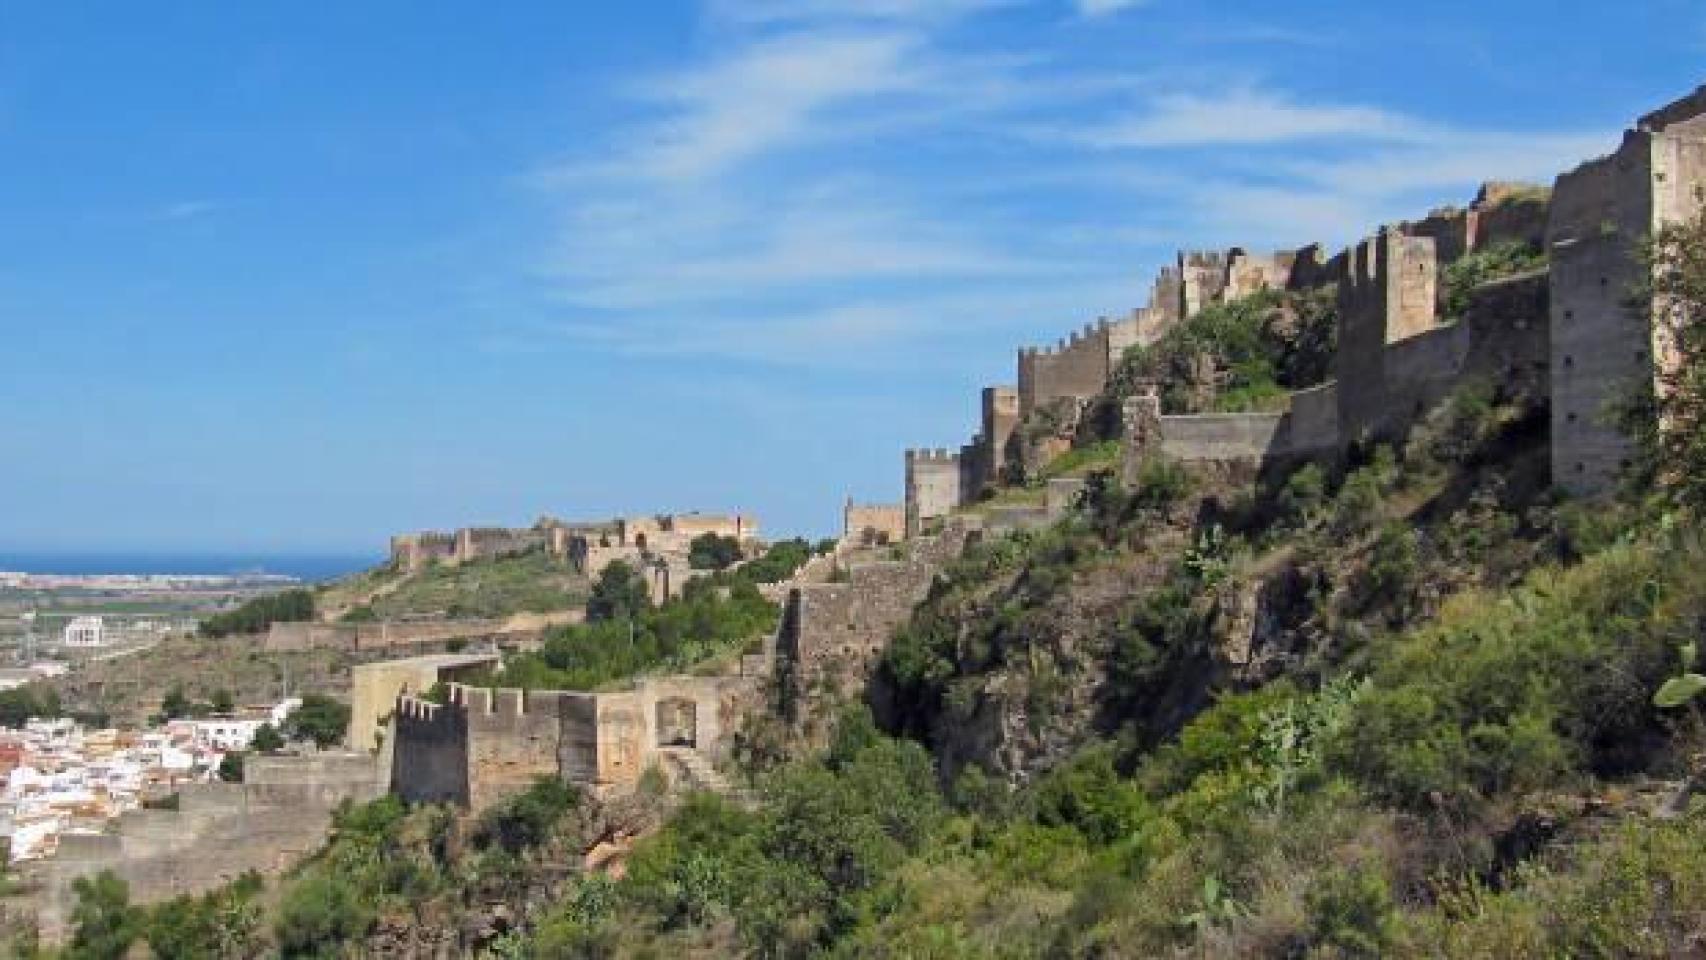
[1636,210,1706,513]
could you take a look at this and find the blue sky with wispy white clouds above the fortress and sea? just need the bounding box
[0,0,1706,552]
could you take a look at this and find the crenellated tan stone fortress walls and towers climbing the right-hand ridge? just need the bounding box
[902,89,1706,525]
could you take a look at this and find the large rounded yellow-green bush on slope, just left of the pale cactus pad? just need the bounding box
[1332,547,1677,810]
